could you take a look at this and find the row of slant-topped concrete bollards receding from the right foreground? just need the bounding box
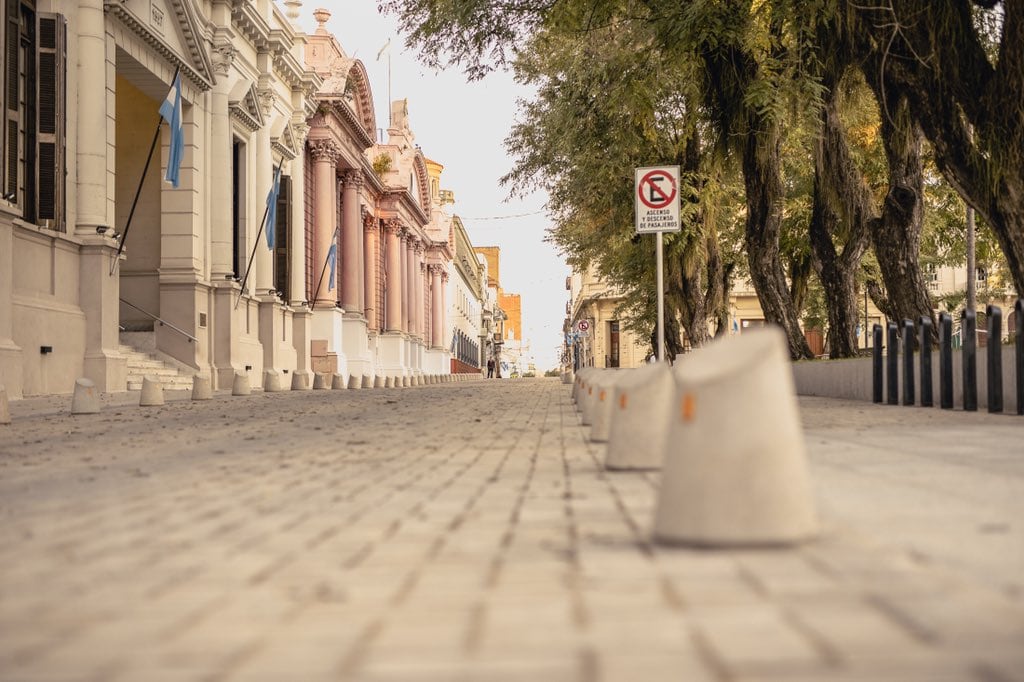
[572,328,818,546]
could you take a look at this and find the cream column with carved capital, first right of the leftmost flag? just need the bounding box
[208,44,236,282]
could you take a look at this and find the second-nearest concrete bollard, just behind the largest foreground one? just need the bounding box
[591,363,675,469]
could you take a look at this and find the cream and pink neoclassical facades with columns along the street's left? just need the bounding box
[0,0,451,397]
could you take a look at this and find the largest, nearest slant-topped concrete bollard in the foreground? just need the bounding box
[654,328,818,546]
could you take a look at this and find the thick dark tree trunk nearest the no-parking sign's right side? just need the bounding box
[743,120,813,359]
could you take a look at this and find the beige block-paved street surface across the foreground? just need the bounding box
[0,380,1024,682]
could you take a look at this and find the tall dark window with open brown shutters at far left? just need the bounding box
[0,0,68,231]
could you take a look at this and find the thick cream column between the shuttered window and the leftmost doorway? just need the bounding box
[75,0,109,237]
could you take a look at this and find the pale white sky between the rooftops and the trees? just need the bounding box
[307,0,569,372]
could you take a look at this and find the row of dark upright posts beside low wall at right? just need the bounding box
[871,299,1024,415]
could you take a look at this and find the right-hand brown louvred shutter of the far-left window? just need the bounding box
[36,13,68,231]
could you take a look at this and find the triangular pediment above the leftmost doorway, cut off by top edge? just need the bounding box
[103,0,216,90]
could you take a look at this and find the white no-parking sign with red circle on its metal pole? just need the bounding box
[635,166,682,363]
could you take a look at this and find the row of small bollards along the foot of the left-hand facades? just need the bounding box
[0,370,480,417]
